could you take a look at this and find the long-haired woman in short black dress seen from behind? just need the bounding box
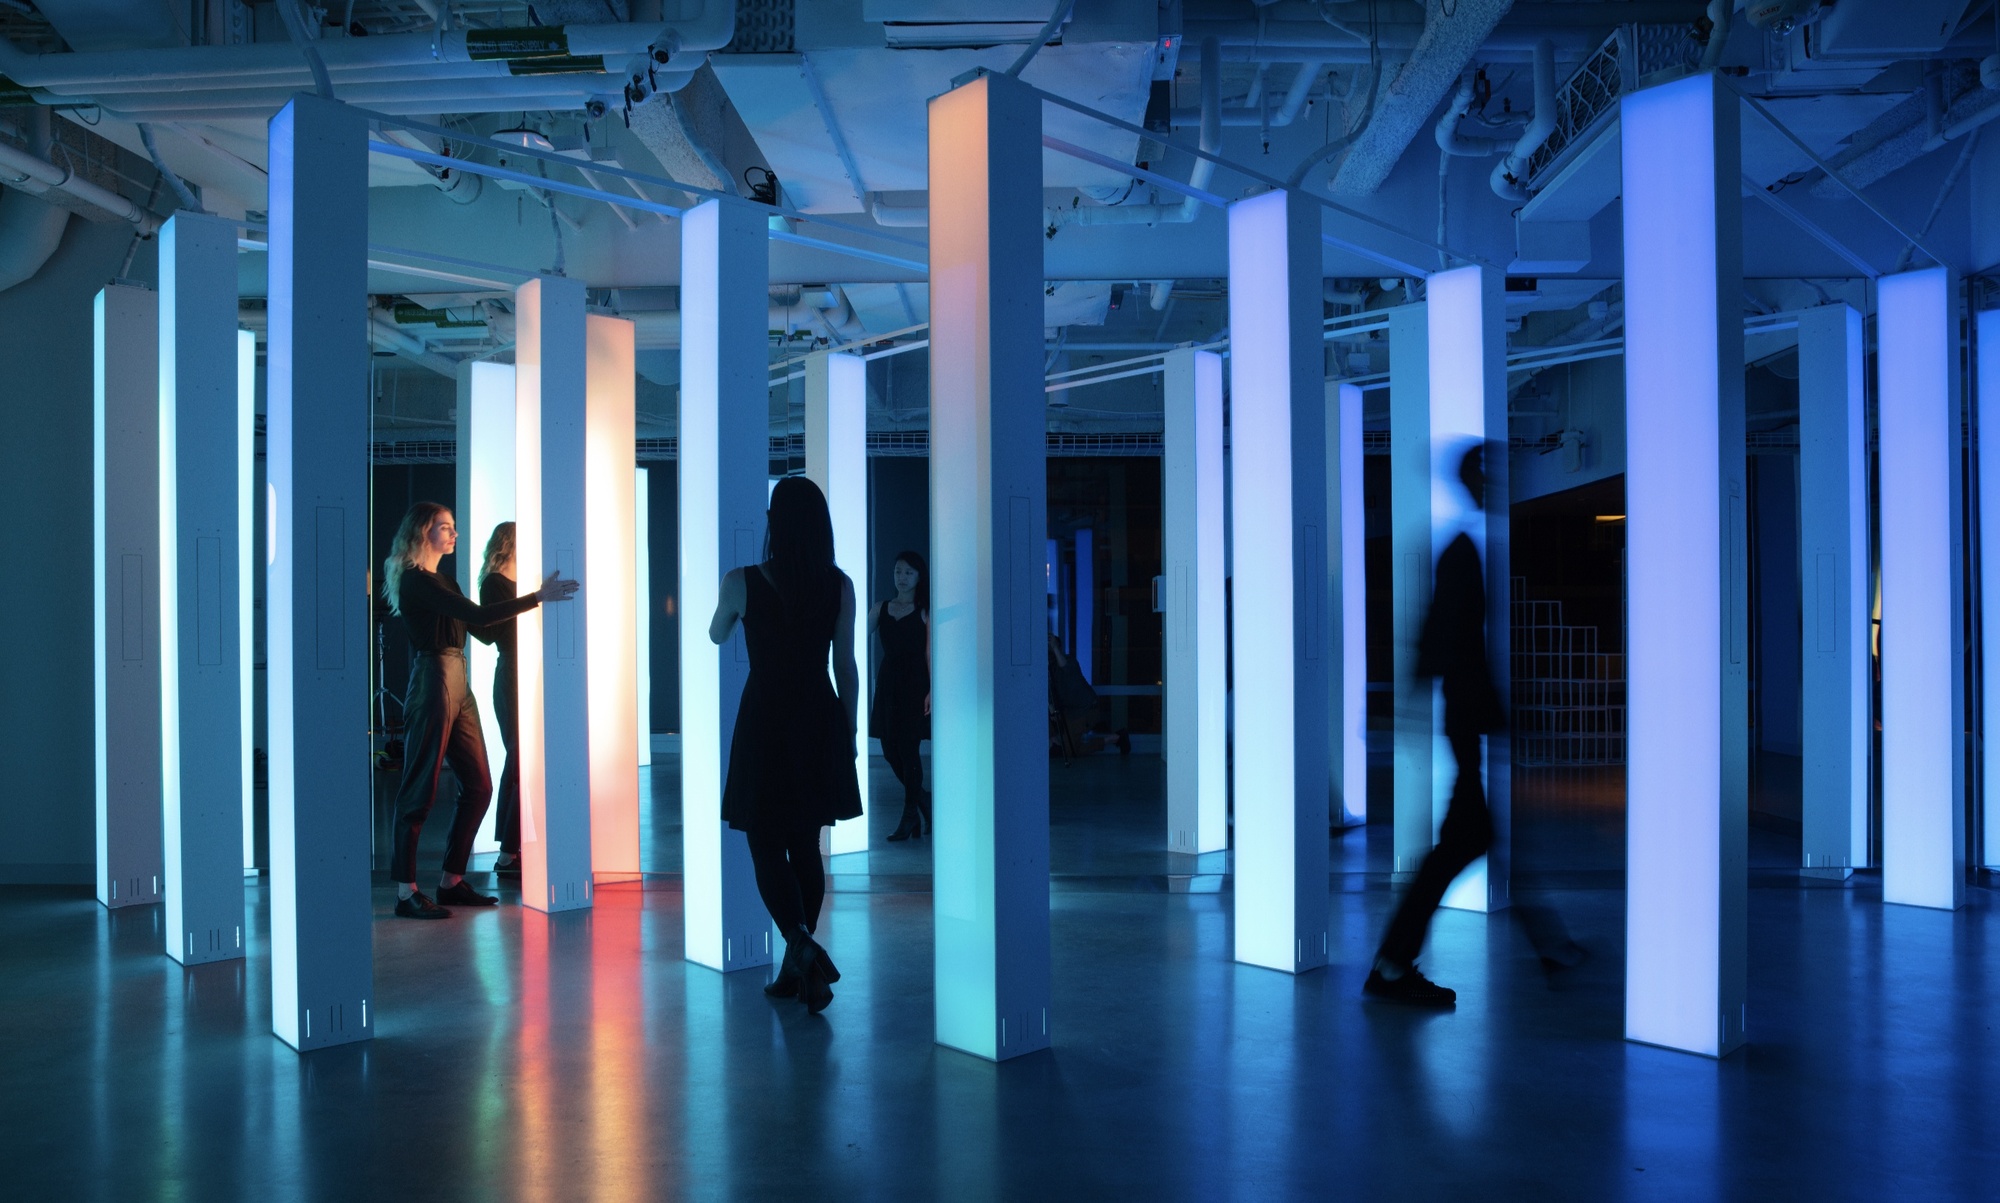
[708,476,862,1013]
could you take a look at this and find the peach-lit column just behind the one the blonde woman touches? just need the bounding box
[584,314,640,881]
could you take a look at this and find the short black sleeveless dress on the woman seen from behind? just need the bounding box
[722,564,862,831]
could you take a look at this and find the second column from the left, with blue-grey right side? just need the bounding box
[160,214,256,965]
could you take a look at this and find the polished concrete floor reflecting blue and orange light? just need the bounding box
[15,757,2000,1203]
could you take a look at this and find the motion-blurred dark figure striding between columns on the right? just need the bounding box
[1362,442,1506,1007]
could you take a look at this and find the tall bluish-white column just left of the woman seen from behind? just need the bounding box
[680,200,772,971]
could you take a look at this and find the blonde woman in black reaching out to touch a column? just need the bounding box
[382,502,576,919]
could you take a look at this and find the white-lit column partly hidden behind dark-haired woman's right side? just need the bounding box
[806,352,870,855]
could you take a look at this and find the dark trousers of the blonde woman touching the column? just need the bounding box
[388,651,494,885]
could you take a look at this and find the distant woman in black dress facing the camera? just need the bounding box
[868,552,930,839]
